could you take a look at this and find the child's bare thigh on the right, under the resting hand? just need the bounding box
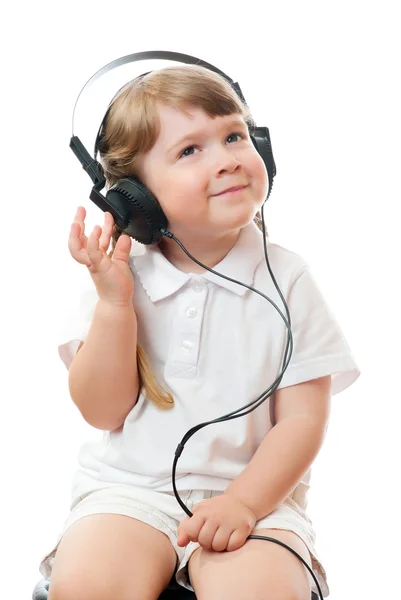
[188,529,311,600]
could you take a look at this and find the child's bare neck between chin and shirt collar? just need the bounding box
[159,229,240,273]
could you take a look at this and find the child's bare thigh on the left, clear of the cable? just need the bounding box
[49,514,177,600]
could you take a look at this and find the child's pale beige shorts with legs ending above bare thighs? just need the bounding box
[39,485,329,598]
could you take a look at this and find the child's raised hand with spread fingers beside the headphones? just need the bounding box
[68,206,134,305]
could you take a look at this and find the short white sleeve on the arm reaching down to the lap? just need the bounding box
[278,265,360,396]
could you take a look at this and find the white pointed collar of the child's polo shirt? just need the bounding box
[130,221,268,302]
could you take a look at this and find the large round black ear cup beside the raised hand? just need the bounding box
[106,177,167,245]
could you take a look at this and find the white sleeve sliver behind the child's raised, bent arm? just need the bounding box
[58,286,99,369]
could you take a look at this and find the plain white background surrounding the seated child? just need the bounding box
[0,0,401,600]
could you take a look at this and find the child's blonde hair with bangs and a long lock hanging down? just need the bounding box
[98,65,263,408]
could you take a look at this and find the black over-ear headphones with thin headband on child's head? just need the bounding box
[70,50,276,244]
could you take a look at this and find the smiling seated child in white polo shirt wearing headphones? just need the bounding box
[40,66,359,600]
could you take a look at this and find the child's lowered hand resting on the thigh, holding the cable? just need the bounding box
[177,494,256,552]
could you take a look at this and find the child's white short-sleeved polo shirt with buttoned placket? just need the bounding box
[59,223,360,507]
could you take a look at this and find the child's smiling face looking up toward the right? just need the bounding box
[137,105,268,239]
